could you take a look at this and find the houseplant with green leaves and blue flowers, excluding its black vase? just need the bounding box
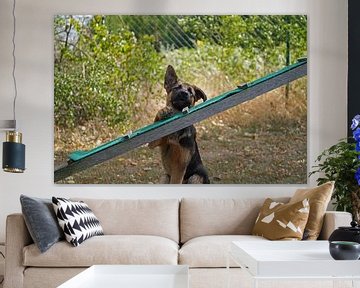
[309,115,360,223]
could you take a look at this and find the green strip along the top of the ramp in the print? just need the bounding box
[69,58,307,161]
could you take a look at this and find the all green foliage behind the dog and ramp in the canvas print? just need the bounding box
[54,15,307,131]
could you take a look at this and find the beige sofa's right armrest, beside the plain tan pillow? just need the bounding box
[319,211,352,240]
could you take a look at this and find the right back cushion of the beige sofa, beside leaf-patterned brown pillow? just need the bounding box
[180,198,289,243]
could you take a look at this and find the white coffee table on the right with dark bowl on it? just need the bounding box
[228,241,360,287]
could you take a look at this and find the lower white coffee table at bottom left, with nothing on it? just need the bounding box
[59,265,189,288]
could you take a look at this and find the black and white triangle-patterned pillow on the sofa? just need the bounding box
[52,197,104,246]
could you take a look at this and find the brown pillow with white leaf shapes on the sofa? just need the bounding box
[252,198,309,240]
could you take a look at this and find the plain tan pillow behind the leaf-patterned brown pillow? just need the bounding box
[289,181,335,240]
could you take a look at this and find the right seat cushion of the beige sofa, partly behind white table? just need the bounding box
[179,235,269,268]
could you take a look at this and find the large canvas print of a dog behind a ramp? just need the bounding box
[54,15,307,184]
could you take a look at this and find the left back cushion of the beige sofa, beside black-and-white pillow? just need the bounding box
[75,199,179,243]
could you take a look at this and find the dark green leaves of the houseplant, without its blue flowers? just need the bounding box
[309,140,360,212]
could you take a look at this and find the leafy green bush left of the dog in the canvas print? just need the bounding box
[54,16,162,130]
